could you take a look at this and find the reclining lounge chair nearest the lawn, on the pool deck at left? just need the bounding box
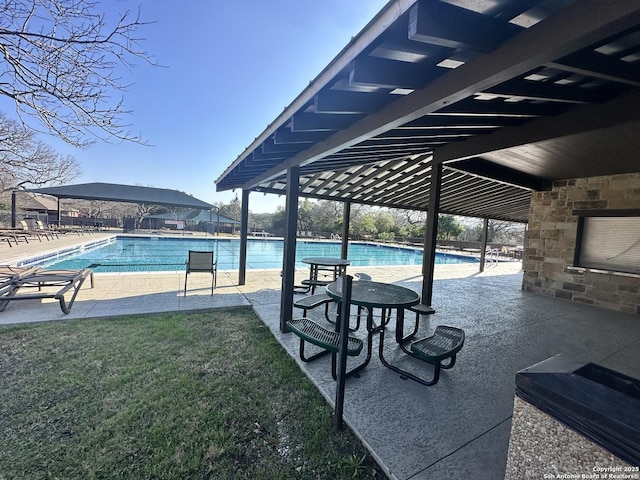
[0,267,93,314]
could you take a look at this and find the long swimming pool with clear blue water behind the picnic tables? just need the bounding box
[24,236,477,273]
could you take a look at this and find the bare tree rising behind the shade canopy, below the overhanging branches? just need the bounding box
[0,113,80,192]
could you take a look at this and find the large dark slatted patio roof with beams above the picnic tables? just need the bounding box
[216,0,640,222]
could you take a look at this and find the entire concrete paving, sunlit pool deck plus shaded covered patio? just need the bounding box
[0,234,640,480]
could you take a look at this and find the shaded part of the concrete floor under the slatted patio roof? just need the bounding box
[246,269,640,480]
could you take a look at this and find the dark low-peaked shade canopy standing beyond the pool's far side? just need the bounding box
[25,183,214,210]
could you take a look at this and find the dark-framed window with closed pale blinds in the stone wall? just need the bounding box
[575,216,640,273]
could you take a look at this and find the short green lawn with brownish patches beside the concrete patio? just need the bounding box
[0,309,384,480]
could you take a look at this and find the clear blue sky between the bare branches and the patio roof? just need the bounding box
[42,0,387,213]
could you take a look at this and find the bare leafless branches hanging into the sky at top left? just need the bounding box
[0,0,155,146]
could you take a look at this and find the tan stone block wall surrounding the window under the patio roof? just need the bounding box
[522,173,640,313]
